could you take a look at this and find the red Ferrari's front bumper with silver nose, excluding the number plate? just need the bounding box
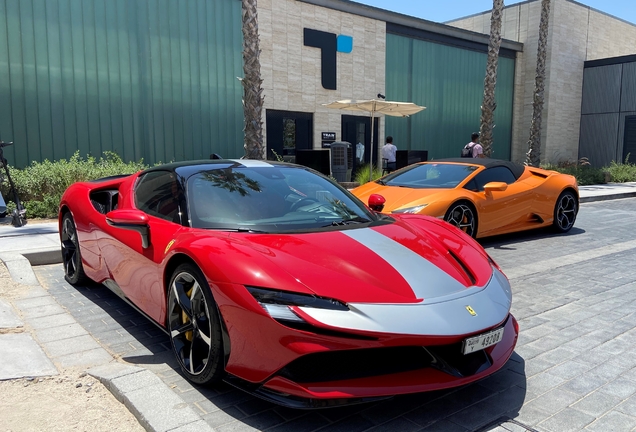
[213,271,518,408]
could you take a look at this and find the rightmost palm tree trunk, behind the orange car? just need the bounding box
[526,0,550,166]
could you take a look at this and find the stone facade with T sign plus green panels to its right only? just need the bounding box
[258,0,523,169]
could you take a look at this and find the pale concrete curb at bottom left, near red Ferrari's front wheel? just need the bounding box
[87,363,214,432]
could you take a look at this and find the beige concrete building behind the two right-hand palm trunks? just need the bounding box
[448,0,636,163]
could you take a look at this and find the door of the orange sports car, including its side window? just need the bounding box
[465,166,530,235]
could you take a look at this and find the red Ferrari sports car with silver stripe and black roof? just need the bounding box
[59,160,518,408]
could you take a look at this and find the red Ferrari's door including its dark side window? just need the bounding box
[100,171,188,323]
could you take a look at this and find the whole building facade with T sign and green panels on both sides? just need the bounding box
[0,0,523,171]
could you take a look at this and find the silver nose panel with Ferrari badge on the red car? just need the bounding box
[300,268,512,336]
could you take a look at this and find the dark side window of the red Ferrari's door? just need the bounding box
[135,171,186,224]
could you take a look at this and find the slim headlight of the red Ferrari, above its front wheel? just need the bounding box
[246,287,349,322]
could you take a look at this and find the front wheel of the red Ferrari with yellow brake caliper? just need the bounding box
[168,264,224,384]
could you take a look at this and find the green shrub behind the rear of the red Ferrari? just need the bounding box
[0,152,148,218]
